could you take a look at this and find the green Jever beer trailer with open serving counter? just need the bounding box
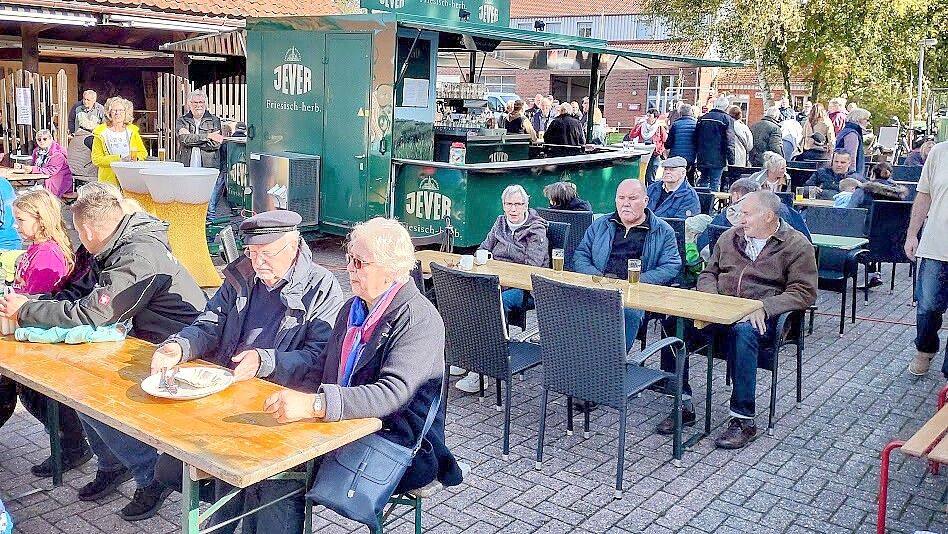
[246,5,729,246]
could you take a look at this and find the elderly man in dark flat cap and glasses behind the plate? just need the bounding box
[151,210,344,532]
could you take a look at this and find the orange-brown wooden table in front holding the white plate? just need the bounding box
[0,336,382,533]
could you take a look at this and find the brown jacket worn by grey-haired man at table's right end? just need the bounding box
[698,222,817,318]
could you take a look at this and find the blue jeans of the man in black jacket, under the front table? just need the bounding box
[79,413,158,488]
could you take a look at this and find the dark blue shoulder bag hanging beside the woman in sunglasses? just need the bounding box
[306,382,444,532]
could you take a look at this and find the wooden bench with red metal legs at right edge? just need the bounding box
[876,386,948,534]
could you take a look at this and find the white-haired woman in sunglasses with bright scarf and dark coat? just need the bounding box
[263,217,462,532]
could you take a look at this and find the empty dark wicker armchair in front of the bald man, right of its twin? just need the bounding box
[532,275,685,499]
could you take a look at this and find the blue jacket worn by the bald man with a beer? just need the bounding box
[573,209,681,286]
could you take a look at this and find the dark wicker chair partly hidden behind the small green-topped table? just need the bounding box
[804,206,868,336]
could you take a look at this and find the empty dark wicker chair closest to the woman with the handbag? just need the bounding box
[431,263,541,460]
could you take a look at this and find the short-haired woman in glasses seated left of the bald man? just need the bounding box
[455,184,550,393]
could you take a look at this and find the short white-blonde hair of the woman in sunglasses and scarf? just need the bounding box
[349,217,417,282]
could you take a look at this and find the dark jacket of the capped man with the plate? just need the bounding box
[162,243,344,391]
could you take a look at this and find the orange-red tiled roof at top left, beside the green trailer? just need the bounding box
[16,0,350,19]
